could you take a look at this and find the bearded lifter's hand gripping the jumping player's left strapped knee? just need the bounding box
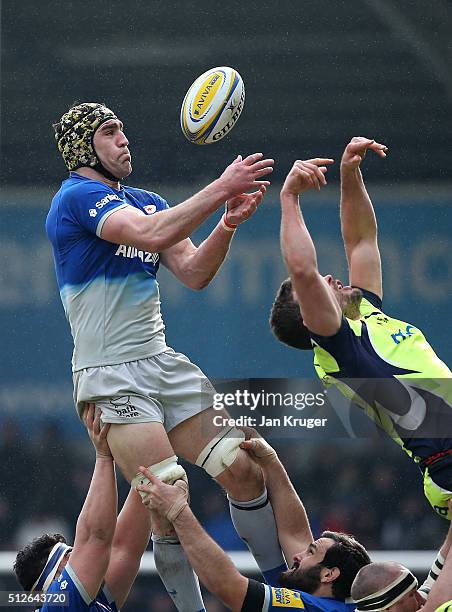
[137,466,188,523]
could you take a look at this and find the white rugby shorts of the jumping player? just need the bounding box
[73,348,215,432]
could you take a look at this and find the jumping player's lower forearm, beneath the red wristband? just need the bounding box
[161,223,234,289]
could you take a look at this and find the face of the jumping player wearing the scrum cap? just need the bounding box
[93,119,132,179]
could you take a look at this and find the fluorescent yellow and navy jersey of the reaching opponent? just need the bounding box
[311,290,452,469]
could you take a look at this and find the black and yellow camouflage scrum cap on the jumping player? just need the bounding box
[53,102,117,170]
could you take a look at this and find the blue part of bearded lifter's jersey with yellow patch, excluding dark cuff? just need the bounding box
[262,584,356,612]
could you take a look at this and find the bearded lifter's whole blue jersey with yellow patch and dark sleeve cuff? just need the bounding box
[241,579,356,612]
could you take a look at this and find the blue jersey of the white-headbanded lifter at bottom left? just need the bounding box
[41,565,118,612]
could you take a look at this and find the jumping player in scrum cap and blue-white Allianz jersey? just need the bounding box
[46,103,284,610]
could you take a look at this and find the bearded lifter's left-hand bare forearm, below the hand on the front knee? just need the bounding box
[173,505,248,612]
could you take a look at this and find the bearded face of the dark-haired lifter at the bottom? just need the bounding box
[279,538,334,594]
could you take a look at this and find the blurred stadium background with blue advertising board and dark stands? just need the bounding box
[0,0,452,612]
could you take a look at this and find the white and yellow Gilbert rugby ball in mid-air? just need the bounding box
[180,66,245,144]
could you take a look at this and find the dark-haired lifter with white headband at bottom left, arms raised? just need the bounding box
[14,404,151,612]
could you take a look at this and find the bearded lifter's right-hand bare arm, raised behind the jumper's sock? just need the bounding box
[261,457,314,565]
